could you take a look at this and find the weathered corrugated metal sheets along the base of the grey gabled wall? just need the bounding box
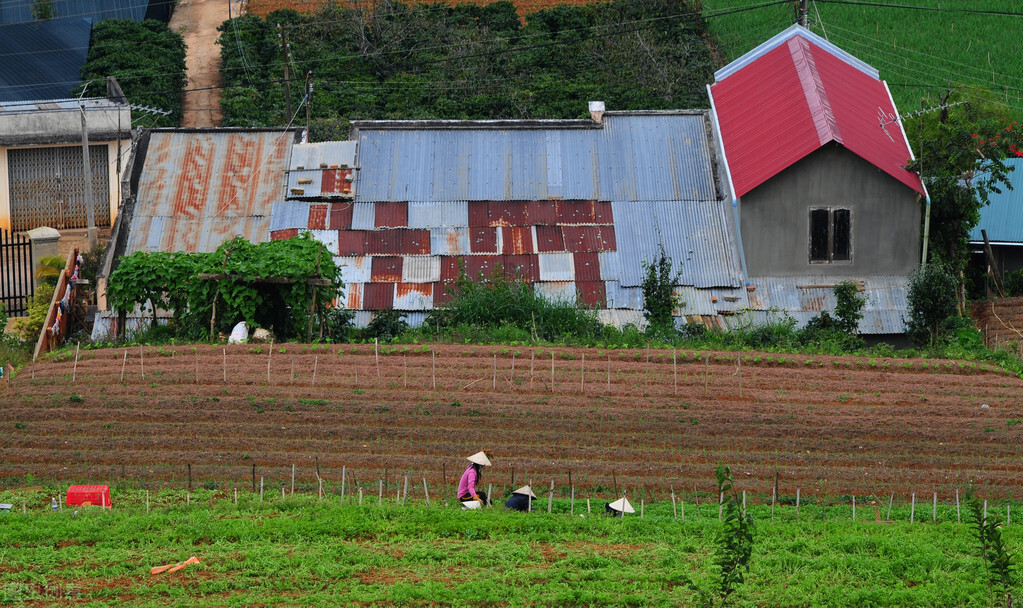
[744,275,909,334]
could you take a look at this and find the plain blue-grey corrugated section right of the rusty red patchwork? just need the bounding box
[601,201,743,288]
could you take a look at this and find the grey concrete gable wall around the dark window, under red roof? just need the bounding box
[740,144,922,276]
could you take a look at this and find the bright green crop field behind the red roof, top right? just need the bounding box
[703,0,1023,118]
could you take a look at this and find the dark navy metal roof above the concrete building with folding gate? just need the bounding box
[0,18,92,101]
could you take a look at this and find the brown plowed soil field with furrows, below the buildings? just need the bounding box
[0,344,1023,497]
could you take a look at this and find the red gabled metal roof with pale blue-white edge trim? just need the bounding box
[710,26,926,197]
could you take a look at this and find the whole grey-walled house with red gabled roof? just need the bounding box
[708,26,927,334]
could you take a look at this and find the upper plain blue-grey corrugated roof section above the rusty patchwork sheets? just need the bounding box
[356,112,717,202]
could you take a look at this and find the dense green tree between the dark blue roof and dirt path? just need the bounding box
[72,19,187,129]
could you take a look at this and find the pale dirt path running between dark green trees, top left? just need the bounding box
[170,0,239,127]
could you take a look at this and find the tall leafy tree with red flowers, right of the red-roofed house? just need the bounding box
[907,88,1023,290]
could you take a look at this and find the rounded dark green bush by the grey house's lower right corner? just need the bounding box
[905,263,959,346]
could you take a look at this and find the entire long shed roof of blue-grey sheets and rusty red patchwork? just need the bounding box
[270,111,745,322]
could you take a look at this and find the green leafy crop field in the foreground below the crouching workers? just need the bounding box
[0,488,1023,607]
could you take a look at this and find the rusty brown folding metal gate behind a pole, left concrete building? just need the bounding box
[7,144,110,231]
